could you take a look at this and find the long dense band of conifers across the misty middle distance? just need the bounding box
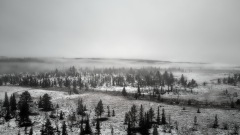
[0,66,197,93]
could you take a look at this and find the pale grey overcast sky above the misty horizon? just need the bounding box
[0,0,240,65]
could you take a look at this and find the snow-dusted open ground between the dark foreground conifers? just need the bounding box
[0,87,240,135]
